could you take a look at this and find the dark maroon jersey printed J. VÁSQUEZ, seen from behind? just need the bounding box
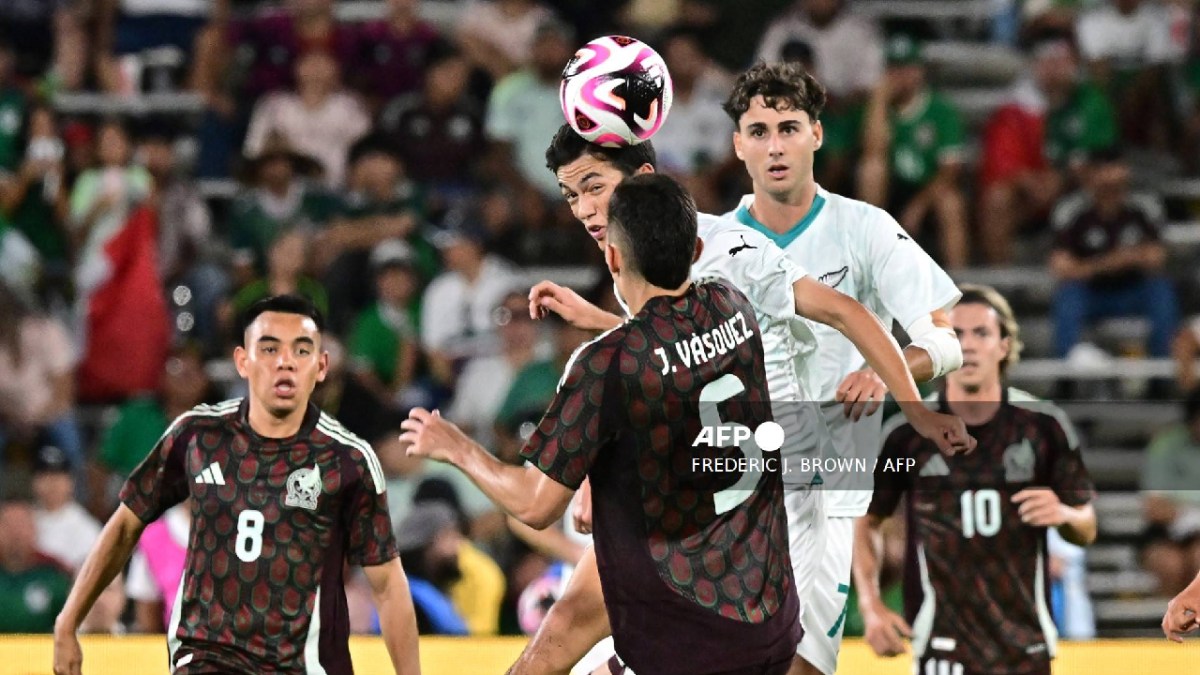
[522,278,802,675]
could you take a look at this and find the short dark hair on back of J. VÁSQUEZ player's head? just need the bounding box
[608,173,696,288]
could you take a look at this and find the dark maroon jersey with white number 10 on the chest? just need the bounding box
[869,388,1093,675]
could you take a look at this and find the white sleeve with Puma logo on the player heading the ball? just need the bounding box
[691,214,808,321]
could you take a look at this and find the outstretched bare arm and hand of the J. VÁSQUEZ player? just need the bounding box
[400,408,575,530]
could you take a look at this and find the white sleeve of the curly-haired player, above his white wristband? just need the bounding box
[856,207,962,329]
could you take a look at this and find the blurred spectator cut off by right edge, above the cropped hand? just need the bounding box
[1141,389,1200,597]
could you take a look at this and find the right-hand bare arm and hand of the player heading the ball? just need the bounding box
[793,276,974,454]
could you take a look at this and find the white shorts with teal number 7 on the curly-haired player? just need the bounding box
[796,516,854,675]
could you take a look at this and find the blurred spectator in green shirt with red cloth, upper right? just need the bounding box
[979,34,1117,265]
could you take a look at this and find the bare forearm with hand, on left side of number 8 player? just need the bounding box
[54,503,145,675]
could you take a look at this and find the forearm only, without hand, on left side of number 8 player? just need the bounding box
[54,504,145,633]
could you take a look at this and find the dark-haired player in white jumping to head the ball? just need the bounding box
[514,125,973,673]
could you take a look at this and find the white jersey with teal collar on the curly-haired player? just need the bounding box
[730,186,961,516]
